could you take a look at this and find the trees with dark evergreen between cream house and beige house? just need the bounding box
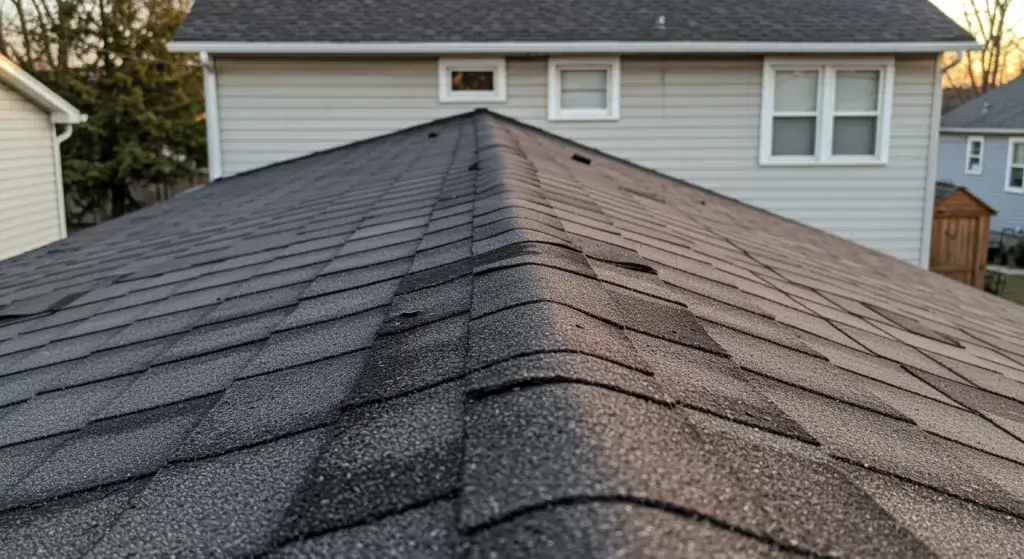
[0,0,206,222]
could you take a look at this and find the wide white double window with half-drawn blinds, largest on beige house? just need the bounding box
[761,58,894,165]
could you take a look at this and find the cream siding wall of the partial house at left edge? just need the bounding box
[0,83,63,260]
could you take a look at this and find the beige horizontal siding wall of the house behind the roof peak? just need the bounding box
[211,57,936,262]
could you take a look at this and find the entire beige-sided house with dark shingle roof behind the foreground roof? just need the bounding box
[171,0,977,265]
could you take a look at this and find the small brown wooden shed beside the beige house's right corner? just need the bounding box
[930,181,995,288]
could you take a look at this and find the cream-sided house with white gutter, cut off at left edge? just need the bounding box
[0,54,86,260]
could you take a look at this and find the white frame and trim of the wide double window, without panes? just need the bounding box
[760,57,896,167]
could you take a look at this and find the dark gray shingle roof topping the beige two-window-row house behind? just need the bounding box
[175,0,973,43]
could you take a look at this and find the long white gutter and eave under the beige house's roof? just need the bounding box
[168,41,982,54]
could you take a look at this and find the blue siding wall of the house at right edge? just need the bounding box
[938,134,1024,230]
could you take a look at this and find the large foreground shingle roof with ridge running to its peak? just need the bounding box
[0,113,1024,557]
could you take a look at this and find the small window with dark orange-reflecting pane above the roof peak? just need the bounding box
[437,58,506,103]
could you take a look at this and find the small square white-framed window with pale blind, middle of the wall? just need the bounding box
[548,58,621,120]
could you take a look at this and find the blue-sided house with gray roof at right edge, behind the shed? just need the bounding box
[938,75,1024,232]
